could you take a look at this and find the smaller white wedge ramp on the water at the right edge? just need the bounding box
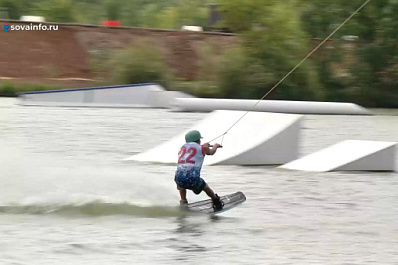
[279,140,397,172]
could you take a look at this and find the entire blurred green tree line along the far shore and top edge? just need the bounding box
[0,0,398,108]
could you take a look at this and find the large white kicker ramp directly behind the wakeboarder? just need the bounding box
[126,111,302,165]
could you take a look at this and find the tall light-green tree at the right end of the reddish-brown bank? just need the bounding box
[221,0,322,100]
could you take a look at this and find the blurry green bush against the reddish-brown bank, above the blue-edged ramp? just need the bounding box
[111,39,172,88]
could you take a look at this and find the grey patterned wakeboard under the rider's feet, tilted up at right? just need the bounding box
[186,191,246,214]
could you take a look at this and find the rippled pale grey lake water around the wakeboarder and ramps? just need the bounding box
[0,98,398,265]
